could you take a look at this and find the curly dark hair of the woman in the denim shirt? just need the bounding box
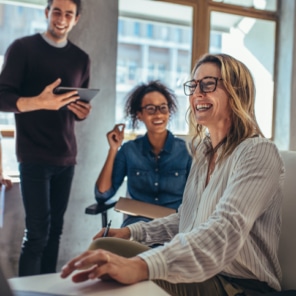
[125,80,177,129]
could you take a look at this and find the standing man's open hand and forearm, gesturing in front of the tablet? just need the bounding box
[16,78,79,112]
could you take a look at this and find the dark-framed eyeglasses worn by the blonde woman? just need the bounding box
[184,76,222,96]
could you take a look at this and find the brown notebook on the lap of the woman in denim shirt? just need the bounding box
[114,197,176,219]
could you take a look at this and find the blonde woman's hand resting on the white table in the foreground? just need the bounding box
[61,249,149,284]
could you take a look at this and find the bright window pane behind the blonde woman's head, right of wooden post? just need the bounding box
[209,11,276,138]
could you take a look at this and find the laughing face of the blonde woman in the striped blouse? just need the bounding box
[189,63,231,129]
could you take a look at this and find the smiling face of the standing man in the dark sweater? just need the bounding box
[45,0,79,42]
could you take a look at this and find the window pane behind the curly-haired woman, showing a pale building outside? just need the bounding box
[116,0,193,134]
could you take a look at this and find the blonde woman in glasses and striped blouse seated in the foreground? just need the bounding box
[61,54,284,296]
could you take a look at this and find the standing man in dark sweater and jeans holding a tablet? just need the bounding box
[0,0,91,276]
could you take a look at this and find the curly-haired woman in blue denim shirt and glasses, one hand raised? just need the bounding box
[95,81,191,226]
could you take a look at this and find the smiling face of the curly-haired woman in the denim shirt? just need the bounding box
[137,91,170,133]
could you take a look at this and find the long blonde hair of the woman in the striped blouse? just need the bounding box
[189,54,264,159]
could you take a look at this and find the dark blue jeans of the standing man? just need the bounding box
[19,163,74,276]
